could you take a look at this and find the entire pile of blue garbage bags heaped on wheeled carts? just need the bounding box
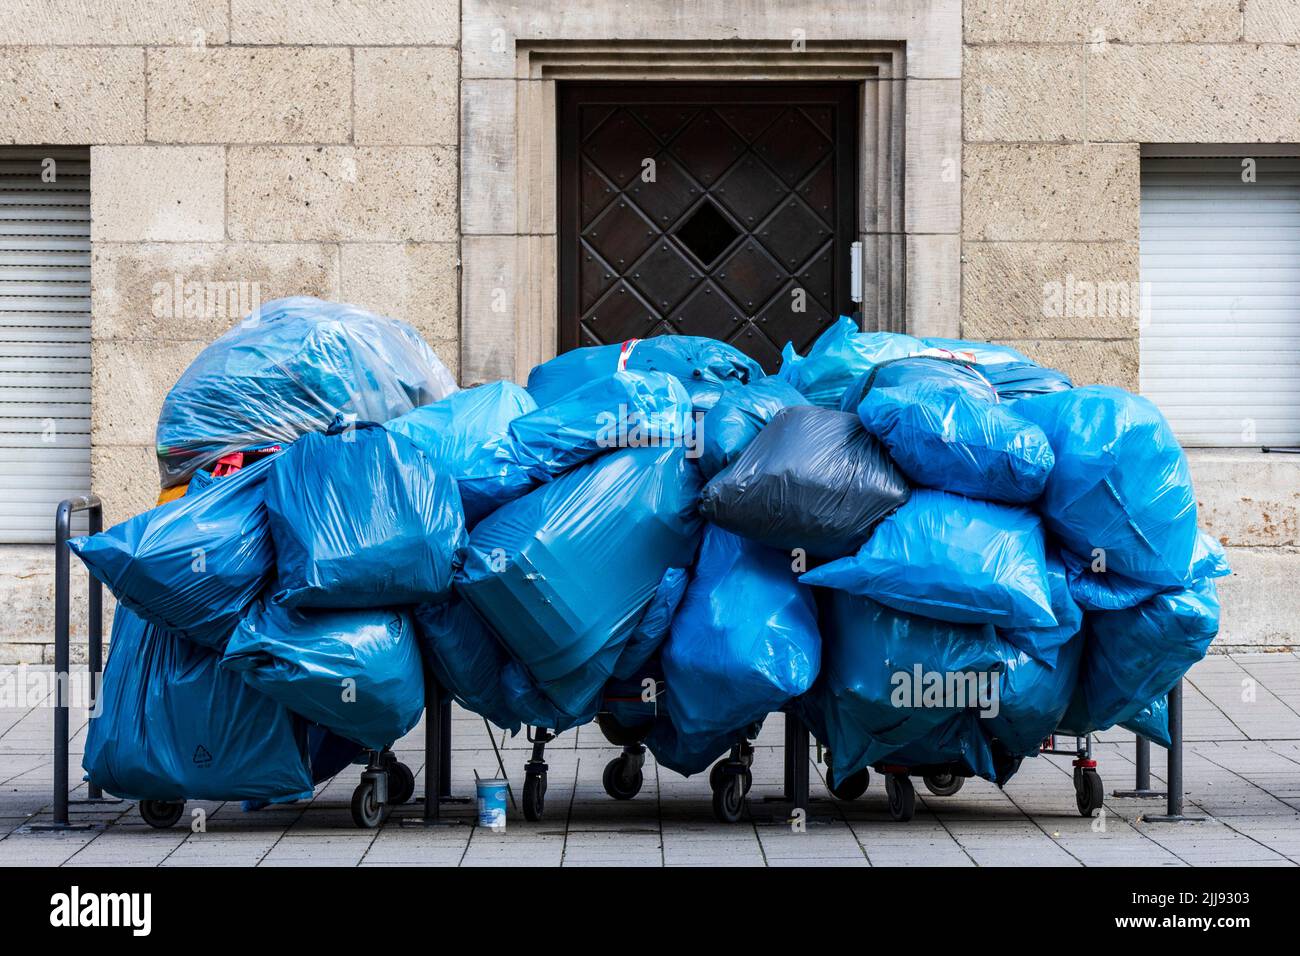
[72,297,1229,804]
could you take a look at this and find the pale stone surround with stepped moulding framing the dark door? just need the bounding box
[460,0,962,385]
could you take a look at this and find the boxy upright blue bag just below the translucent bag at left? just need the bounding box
[267,424,467,607]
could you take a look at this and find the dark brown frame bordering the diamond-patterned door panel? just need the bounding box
[555,79,862,352]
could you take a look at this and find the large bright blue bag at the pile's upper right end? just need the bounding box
[1015,385,1196,587]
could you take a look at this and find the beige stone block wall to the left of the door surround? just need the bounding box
[0,0,460,663]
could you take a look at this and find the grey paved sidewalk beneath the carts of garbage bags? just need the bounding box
[0,653,1300,866]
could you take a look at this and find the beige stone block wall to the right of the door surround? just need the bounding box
[962,0,1300,650]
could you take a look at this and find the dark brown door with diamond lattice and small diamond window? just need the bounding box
[559,83,858,371]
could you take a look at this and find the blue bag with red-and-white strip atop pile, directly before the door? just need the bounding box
[528,336,763,410]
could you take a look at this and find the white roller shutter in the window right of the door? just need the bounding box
[1141,156,1300,447]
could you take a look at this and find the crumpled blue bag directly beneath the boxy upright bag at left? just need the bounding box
[221,604,424,750]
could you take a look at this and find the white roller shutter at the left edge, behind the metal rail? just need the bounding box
[0,147,90,544]
